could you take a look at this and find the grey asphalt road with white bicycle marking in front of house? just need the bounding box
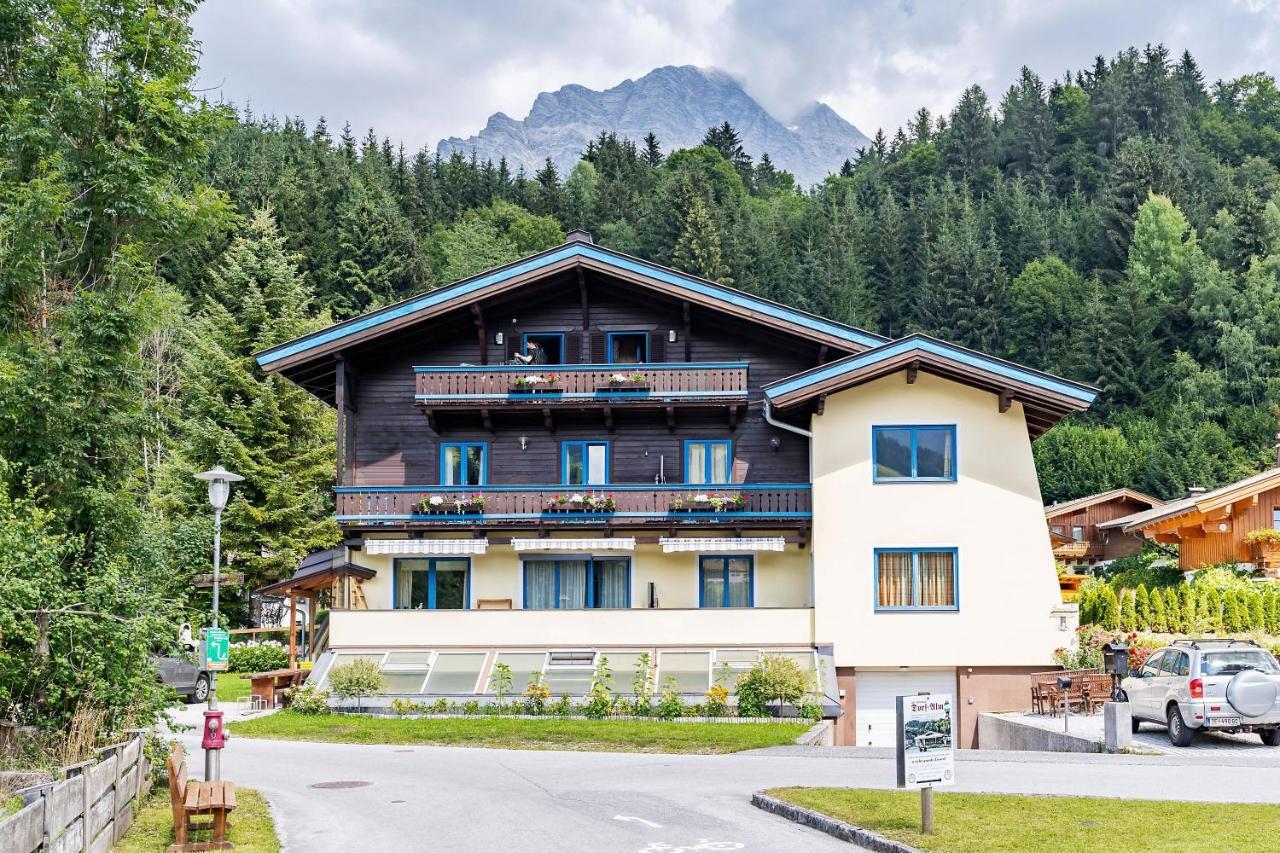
[175,701,1280,853]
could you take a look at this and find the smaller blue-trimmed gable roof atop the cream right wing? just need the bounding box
[764,334,1098,435]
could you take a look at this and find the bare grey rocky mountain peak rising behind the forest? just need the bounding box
[436,65,869,184]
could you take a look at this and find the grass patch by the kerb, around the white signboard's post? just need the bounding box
[765,771,1280,853]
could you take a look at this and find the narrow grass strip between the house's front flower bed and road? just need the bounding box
[229,711,809,753]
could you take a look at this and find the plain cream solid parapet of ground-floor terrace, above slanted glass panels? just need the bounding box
[329,607,813,649]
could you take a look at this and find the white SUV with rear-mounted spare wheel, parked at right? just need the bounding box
[1121,639,1280,747]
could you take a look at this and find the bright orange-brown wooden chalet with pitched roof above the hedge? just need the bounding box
[1111,467,1280,578]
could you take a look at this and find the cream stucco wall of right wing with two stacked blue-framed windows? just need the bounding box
[812,371,1070,667]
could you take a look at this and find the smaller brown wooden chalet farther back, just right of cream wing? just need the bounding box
[1044,488,1164,566]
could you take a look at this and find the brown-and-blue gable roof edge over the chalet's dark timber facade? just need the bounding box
[255,241,887,373]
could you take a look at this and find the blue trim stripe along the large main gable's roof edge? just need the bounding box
[255,243,884,368]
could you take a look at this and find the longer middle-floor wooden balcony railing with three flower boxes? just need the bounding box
[335,483,812,526]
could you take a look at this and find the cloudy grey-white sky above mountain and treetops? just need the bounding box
[193,0,1280,150]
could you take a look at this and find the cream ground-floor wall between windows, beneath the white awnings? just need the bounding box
[351,532,809,615]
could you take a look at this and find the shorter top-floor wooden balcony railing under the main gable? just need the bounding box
[413,361,748,407]
